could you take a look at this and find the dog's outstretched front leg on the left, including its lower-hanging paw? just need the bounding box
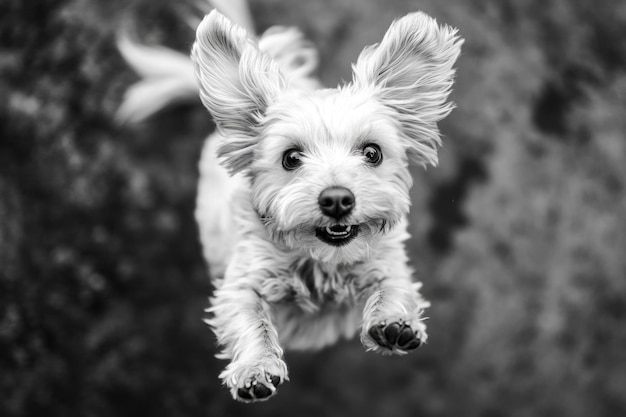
[209,272,288,402]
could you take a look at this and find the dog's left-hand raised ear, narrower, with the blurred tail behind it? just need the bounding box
[191,10,285,173]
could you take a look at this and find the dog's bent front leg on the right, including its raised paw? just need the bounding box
[361,278,428,355]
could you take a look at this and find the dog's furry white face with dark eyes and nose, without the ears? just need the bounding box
[249,90,411,262]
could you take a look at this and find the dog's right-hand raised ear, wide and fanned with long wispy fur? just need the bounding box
[352,12,463,166]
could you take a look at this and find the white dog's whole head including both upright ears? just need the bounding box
[192,12,462,263]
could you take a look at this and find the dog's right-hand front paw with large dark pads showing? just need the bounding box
[362,320,427,354]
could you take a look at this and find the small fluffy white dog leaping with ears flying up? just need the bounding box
[118,0,462,402]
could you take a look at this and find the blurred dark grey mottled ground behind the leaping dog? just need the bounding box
[0,0,626,417]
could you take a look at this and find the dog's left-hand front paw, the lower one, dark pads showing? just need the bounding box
[220,359,289,403]
